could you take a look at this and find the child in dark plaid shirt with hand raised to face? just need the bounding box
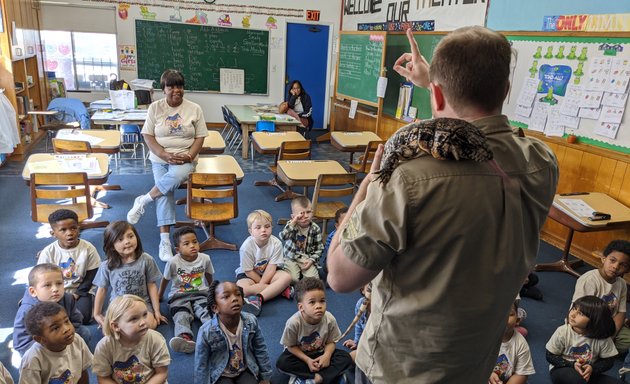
[280,196,324,283]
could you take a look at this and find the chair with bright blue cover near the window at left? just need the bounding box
[39,97,90,152]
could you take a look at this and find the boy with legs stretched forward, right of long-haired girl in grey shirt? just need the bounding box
[158,227,214,353]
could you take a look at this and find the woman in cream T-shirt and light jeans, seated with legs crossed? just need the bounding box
[127,69,208,261]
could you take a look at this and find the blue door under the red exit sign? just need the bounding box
[284,23,329,128]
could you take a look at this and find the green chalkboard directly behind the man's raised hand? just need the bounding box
[383,33,445,119]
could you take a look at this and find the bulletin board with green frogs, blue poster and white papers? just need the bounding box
[503,32,630,154]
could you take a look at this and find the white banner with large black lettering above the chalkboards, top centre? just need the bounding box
[342,0,488,31]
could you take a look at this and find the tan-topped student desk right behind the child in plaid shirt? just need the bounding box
[276,160,347,201]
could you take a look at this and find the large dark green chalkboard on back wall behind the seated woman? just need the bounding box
[136,20,269,94]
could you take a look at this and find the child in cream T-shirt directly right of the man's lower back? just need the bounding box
[488,300,536,384]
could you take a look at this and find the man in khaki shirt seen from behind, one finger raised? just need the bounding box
[328,27,558,383]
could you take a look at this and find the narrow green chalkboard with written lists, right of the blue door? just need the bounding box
[337,32,385,105]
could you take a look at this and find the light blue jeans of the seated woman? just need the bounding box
[151,163,197,227]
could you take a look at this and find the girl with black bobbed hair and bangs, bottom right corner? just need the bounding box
[546,296,621,384]
